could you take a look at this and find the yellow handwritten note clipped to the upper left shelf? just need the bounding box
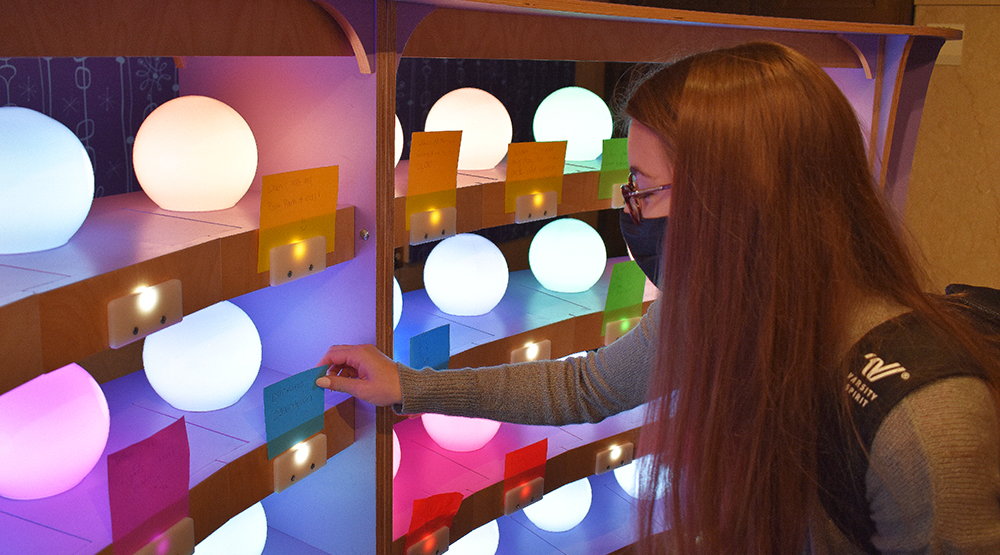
[257,166,340,272]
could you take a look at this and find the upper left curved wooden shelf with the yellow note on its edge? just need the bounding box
[0,192,355,393]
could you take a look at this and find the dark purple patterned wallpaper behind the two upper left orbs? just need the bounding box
[0,57,178,197]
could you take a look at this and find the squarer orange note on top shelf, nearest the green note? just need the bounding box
[504,141,566,213]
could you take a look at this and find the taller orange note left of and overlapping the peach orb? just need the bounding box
[406,131,462,229]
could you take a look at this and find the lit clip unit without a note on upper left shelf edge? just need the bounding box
[108,279,184,349]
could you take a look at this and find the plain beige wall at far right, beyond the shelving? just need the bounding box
[905,0,1000,291]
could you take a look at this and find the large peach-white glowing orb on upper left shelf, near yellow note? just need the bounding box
[132,95,257,212]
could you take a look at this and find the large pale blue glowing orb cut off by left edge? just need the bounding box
[0,106,94,254]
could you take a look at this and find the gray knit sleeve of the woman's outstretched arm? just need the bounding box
[393,301,659,426]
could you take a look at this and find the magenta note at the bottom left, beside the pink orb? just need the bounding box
[108,417,191,555]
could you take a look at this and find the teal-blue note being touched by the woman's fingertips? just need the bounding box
[264,366,327,460]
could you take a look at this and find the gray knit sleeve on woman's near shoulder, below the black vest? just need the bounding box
[867,377,1000,554]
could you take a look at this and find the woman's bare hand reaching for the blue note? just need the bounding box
[316,345,403,406]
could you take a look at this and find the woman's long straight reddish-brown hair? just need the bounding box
[625,43,988,555]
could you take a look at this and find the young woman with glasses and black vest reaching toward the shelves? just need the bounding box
[317,43,1000,555]
